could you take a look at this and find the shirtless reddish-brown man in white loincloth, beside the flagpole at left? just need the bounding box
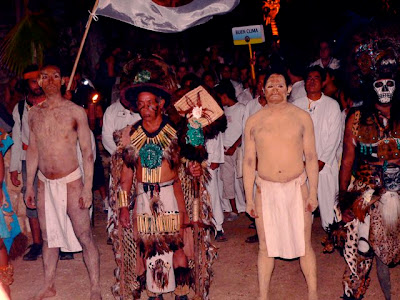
[26,66,101,300]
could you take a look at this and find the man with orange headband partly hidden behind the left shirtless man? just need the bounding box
[10,65,45,261]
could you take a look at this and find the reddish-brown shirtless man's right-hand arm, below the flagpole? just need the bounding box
[75,108,94,209]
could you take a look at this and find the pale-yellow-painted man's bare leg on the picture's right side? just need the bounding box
[300,184,318,300]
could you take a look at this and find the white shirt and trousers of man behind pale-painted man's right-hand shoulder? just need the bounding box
[293,94,343,229]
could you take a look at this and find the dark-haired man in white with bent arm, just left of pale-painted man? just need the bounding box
[215,79,246,221]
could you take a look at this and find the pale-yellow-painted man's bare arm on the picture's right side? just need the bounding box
[303,114,319,212]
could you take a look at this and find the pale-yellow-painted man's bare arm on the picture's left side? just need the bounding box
[243,118,258,218]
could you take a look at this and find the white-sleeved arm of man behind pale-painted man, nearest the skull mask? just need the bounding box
[318,103,342,171]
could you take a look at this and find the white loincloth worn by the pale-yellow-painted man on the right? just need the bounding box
[256,172,307,259]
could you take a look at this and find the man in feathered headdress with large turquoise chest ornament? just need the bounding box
[110,57,217,300]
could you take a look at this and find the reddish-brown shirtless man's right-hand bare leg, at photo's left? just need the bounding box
[67,179,101,300]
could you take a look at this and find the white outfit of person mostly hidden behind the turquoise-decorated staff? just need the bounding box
[206,133,224,231]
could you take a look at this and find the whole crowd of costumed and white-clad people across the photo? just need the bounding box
[0,20,400,300]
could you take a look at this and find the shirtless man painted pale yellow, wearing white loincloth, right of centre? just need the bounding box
[243,74,318,300]
